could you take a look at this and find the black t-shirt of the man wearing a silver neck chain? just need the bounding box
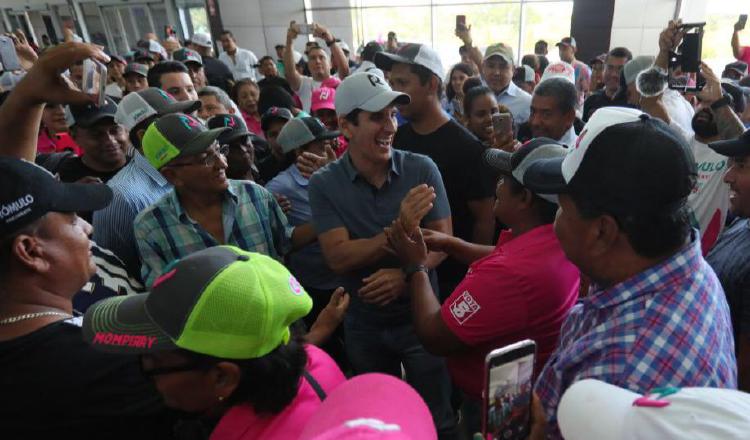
[0,318,175,439]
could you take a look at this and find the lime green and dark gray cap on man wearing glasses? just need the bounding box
[141,113,229,170]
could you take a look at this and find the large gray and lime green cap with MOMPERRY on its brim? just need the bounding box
[83,246,312,359]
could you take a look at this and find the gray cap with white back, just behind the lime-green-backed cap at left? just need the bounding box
[115,87,201,132]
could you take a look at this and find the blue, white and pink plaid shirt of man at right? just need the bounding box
[535,234,737,438]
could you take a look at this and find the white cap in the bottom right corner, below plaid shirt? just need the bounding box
[557,379,750,440]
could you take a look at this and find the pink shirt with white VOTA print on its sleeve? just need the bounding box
[441,225,579,399]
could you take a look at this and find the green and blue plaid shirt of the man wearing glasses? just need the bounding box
[133,180,293,286]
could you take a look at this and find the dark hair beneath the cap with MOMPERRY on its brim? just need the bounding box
[178,337,307,414]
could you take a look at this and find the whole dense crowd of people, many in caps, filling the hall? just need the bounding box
[0,12,750,440]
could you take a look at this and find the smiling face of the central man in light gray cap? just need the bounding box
[339,105,398,165]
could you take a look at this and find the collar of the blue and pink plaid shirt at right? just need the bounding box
[582,231,703,309]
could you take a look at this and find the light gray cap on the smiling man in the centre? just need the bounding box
[336,72,411,116]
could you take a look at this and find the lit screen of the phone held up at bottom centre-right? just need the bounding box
[485,345,534,440]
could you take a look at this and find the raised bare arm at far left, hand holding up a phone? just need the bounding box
[0,43,109,161]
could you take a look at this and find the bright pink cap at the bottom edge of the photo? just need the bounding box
[299,373,437,440]
